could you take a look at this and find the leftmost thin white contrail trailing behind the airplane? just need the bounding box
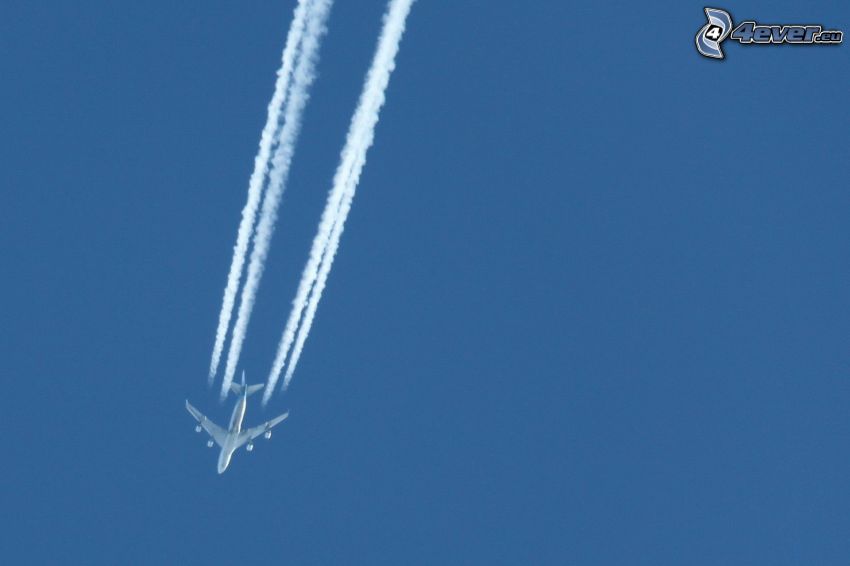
[209,0,312,385]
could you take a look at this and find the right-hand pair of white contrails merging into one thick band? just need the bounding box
[263,0,414,404]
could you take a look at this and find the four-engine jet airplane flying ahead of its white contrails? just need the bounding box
[186,371,289,474]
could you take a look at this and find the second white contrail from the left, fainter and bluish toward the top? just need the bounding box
[221,0,333,399]
